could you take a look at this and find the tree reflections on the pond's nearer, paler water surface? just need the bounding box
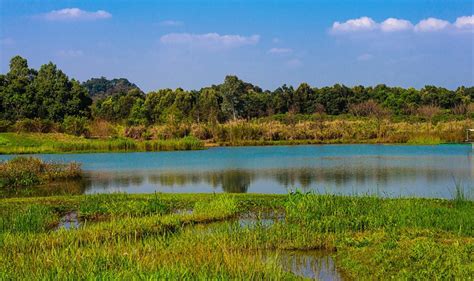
[78,162,470,197]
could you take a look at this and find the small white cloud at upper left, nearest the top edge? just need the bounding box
[41,8,112,21]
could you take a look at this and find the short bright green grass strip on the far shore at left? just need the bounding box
[0,133,203,154]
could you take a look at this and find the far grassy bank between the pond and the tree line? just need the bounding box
[0,117,474,154]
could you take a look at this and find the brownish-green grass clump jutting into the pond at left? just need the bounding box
[0,157,82,187]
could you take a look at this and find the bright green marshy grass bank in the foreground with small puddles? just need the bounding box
[0,193,474,280]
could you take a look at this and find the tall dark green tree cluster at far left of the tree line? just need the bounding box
[0,56,92,121]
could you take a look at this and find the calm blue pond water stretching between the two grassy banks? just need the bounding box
[0,145,474,198]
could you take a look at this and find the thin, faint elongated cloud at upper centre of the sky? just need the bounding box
[160,33,260,49]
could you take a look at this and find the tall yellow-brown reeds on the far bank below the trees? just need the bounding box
[157,118,474,145]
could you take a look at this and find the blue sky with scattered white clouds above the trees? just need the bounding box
[0,0,474,91]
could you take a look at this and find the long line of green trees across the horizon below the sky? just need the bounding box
[0,56,474,125]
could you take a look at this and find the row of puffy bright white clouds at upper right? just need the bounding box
[331,15,474,34]
